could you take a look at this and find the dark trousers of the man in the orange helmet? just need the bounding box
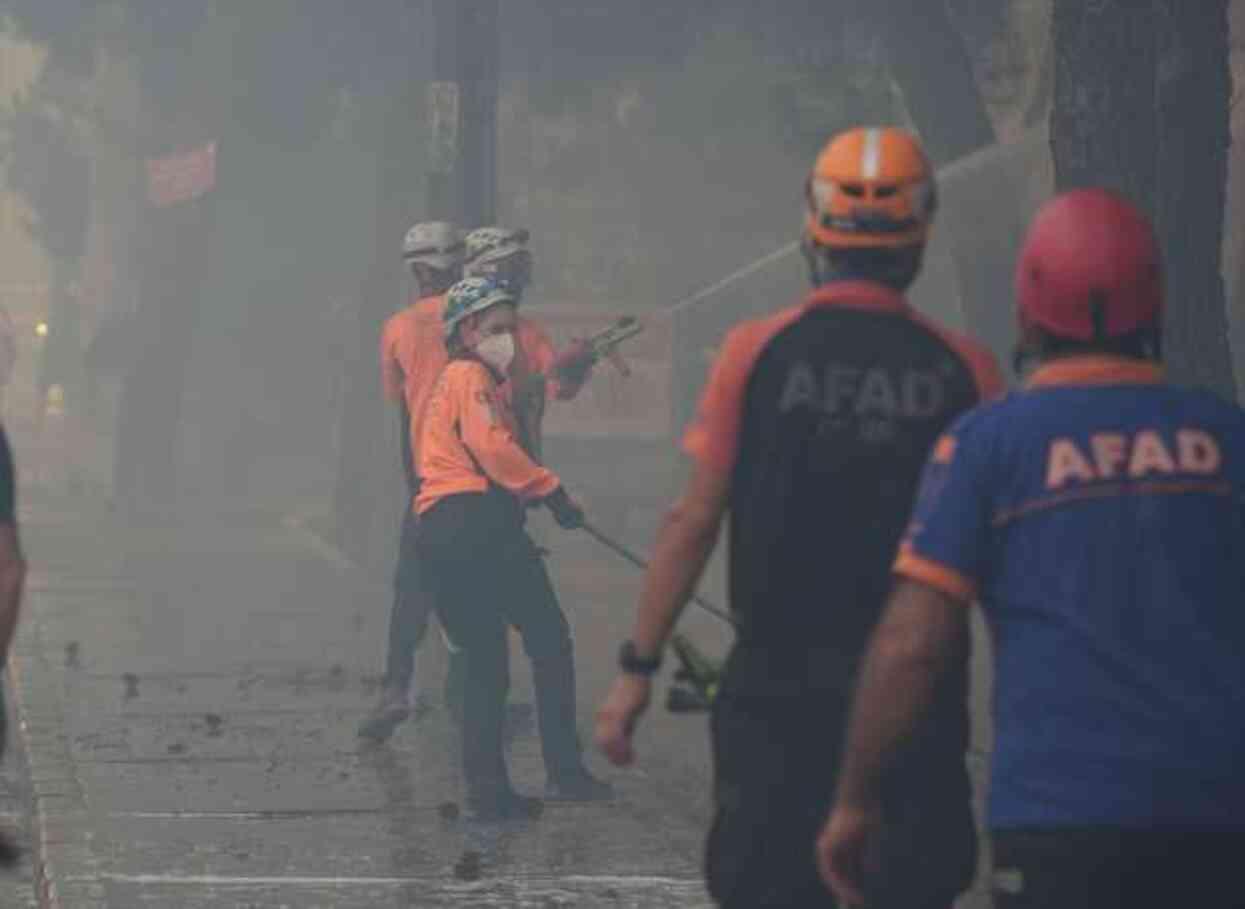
[705,695,976,909]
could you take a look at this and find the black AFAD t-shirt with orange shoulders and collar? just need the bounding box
[685,283,1002,695]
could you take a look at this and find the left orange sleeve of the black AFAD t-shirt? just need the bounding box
[684,320,774,472]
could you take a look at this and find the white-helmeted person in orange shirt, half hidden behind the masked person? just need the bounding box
[359,222,463,742]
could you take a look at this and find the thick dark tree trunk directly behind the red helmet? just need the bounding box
[1051,0,1235,397]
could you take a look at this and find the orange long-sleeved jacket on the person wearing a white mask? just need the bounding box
[415,360,561,514]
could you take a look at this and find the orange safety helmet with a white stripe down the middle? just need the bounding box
[804,127,937,249]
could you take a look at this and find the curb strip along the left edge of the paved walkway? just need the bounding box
[9,600,107,909]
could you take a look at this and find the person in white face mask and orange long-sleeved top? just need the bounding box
[416,278,611,818]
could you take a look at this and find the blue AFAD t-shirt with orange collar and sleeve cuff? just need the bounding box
[896,357,1245,829]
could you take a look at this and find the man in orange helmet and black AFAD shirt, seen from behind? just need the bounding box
[596,128,1002,909]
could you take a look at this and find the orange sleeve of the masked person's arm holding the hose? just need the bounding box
[456,366,560,501]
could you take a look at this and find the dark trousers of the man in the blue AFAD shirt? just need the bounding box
[992,819,1245,909]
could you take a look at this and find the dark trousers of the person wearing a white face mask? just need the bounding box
[417,492,581,797]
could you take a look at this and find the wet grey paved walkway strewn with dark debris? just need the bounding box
[0,495,979,909]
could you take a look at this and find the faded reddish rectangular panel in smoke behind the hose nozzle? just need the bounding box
[522,303,674,440]
